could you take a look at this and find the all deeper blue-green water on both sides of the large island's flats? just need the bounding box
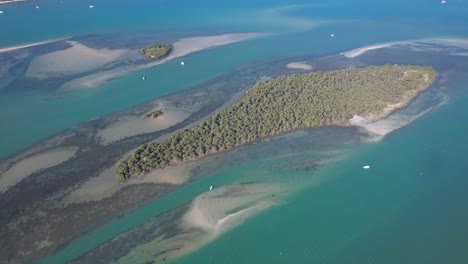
[0,0,468,264]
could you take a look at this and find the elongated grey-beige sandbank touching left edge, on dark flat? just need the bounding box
[0,147,78,192]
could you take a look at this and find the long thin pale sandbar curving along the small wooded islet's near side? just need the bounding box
[61,33,266,89]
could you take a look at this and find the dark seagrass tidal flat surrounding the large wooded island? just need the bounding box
[0,39,468,263]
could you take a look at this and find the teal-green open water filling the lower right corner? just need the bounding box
[176,89,468,263]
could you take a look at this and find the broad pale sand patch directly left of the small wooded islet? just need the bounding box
[25,41,135,79]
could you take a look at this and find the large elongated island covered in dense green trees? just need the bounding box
[118,65,437,181]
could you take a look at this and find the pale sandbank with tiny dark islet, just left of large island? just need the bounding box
[97,102,189,144]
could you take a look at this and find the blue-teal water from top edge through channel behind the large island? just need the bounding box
[0,1,466,159]
